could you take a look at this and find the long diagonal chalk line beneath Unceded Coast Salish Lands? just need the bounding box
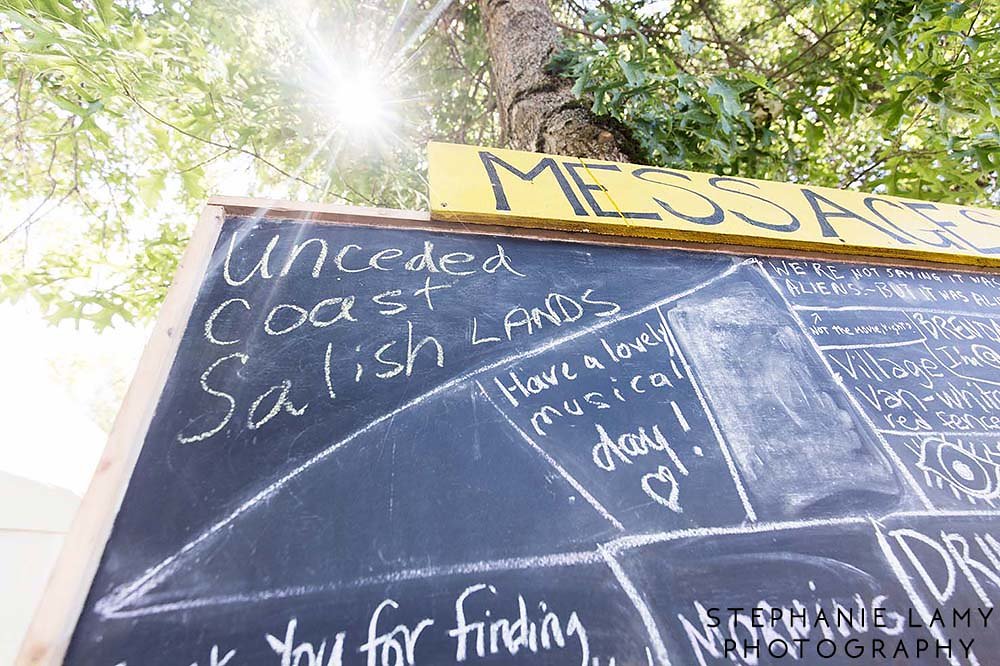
[95,258,758,616]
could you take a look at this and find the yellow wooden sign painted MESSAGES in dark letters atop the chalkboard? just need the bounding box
[428,143,1000,266]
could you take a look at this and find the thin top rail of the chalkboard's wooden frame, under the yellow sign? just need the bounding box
[209,197,997,274]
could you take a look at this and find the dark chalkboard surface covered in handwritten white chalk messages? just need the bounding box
[21,202,1000,666]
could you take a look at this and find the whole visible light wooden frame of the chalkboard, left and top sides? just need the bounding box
[16,197,991,666]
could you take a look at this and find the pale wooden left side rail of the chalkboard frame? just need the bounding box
[14,205,224,666]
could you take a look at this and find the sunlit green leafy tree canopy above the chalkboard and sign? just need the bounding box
[0,0,1000,327]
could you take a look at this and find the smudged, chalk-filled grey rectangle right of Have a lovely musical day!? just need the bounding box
[668,271,902,519]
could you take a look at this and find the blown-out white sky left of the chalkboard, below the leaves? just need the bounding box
[0,158,262,496]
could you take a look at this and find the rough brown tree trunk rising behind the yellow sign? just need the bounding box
[479,0,637,162]
